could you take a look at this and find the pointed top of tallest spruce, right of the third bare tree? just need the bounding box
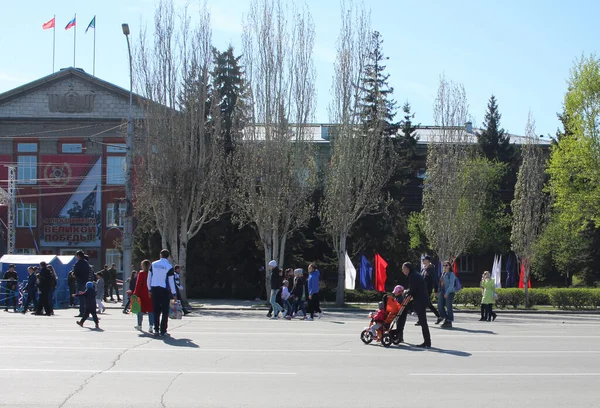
[359,31,400,136]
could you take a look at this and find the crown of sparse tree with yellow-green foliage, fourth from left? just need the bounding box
[423,77,501,260]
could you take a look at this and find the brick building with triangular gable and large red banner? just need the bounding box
[0,68,142,266]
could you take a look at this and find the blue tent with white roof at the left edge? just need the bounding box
[0,255,76,306]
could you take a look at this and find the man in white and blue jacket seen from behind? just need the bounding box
[148,249,176,336]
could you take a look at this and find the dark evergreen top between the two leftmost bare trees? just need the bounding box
[212,46,247,153]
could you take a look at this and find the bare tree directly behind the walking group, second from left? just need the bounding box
[232,0,315,293]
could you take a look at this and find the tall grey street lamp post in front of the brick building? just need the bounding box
[121,23,133,302]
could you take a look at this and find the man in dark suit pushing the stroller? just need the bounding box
[398,262,431,348]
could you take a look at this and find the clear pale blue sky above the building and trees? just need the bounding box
[0,0,600,134]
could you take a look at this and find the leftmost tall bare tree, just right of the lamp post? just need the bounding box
[136,0,226,300]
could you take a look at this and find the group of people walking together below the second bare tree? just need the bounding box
[267,260,323,321]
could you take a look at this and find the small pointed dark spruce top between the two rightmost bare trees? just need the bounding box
[477,95,514,163]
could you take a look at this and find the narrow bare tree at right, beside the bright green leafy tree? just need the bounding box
[510,112,548,307]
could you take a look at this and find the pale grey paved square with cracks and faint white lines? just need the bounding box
[0,309,600,408]
